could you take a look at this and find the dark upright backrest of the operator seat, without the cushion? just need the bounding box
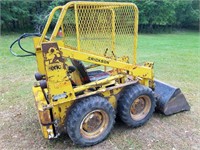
[71,59,91,84]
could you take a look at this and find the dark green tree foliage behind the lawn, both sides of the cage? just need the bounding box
[0,0,200,33]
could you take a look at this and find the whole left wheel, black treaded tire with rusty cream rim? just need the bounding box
[65,96,116,146]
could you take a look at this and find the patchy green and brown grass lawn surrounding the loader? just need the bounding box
[0,32,200,150]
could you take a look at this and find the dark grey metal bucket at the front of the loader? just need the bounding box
[154,80,190,115]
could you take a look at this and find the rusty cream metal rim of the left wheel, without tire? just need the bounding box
[80,110,109,139]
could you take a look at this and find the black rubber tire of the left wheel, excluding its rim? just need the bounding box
[65,96,115,146]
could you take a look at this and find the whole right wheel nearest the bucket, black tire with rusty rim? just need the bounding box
[118,84,156,127]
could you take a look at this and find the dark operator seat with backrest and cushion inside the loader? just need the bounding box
[71,59,110,84]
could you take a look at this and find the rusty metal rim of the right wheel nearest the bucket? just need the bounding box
[130,95,151,120]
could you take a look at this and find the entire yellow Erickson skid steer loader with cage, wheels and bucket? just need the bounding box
[11,1,190,146]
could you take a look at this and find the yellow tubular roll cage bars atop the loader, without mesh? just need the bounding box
[38,1,138,65]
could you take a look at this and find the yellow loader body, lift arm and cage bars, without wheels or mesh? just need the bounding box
[33,1,154,138]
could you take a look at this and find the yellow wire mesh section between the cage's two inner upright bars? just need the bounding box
[78,6,113,55]
